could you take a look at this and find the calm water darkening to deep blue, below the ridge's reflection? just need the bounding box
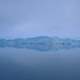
[0,48,80,80]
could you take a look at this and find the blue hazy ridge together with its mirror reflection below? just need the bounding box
[0,36,80,51]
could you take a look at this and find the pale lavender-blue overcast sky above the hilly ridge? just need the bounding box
[0,0,80,38]
